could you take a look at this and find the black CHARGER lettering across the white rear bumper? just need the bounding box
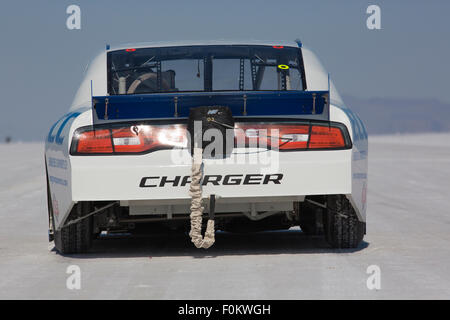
[139,173,283,188]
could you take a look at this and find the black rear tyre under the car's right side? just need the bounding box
[324,195,365,248]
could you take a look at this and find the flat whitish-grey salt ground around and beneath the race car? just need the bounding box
[0,134,450,299]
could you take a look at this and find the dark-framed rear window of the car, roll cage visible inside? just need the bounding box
[108,45,306,95]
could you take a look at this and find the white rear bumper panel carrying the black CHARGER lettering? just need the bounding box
[70,150,352,202]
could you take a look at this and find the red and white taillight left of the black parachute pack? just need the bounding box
[71,125,187,154]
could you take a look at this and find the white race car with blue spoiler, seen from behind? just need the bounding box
[45,41,368,253]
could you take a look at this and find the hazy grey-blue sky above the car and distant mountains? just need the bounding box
[0,0,450,140]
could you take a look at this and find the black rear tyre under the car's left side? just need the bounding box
[54,202,93,254]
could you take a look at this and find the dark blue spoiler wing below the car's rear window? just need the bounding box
[92,91,330,124]
